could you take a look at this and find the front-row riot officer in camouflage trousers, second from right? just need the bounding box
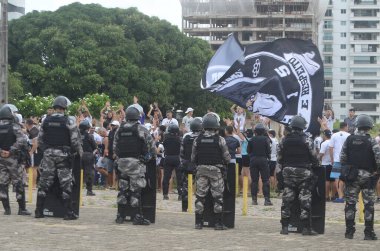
[277,116,318,235]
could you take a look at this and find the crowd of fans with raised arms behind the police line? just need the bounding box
[11,97,380,203]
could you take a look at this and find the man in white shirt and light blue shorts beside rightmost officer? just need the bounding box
[329,122,350,203]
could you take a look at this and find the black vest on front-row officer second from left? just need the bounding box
[42,116,71,147]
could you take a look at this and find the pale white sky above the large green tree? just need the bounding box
[25,0,182,29]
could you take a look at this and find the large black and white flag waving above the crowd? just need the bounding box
[201,35,324,133]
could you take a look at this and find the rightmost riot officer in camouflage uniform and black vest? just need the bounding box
[340,114,380,240]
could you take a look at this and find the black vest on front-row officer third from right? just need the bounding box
[196,134,223,165]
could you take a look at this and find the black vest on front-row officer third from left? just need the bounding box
[116,124,147,158]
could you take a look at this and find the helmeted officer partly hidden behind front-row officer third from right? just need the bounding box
[180,117,202,212]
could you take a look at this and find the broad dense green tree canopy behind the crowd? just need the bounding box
[9,3,230,115]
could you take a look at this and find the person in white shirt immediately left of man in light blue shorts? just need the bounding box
[319,130,336,201]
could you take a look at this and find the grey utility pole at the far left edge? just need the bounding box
[0,0,8,105]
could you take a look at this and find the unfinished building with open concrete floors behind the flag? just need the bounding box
[180,0,327,49]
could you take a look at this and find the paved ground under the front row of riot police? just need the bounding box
[0,191,380,251]
